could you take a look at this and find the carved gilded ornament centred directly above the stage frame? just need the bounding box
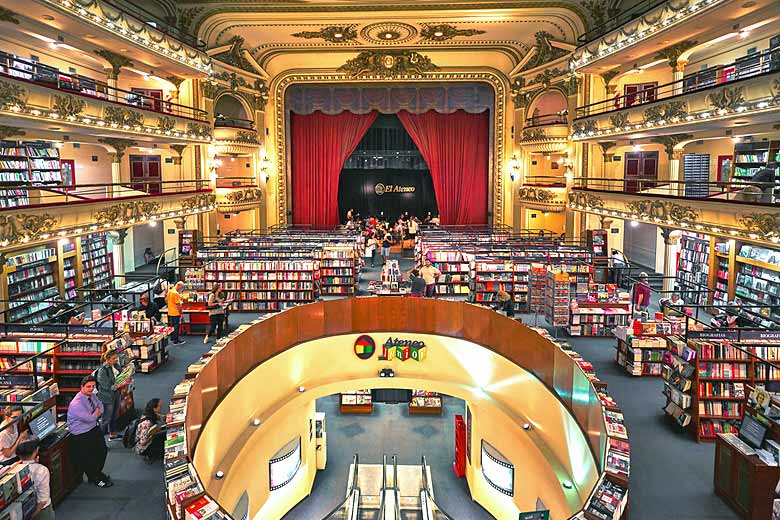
[338,50,439,78]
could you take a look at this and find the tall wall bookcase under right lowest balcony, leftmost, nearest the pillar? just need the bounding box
[676,231,713,305]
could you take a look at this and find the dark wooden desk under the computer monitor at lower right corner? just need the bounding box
[714,435,780,520]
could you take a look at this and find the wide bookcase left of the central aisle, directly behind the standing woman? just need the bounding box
[204,260,320,312]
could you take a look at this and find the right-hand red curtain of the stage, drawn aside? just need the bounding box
[398,110,490,224]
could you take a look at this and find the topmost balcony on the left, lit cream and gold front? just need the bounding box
[3,0,213,77]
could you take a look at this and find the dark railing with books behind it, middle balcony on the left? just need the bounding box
[0,51,208,121]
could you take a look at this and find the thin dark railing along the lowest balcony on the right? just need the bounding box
[574,177,780,205]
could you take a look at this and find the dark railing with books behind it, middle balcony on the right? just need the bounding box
[577,48,780,119]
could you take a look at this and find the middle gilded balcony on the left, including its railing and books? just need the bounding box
[0,52,212,142]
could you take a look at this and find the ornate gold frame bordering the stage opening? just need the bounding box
[268,69,509,225]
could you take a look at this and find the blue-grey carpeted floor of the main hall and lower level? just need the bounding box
[56,254,738,520]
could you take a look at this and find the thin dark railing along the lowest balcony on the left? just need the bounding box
[0,179,211,214]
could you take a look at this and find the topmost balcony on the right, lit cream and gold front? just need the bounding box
[571,0,777,73]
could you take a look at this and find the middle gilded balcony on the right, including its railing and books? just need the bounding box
[572,47,780,140]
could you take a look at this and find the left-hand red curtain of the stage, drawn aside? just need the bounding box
[290,112,379,229]
